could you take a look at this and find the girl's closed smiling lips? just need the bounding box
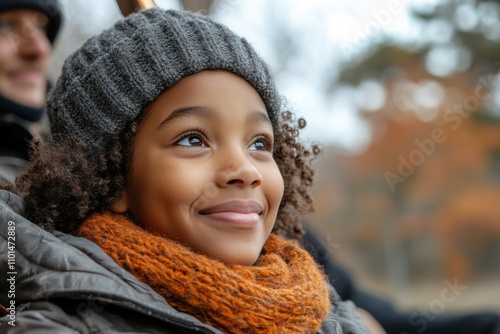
[199,201,263,228]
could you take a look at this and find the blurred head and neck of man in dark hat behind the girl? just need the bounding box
[0,0,62,183]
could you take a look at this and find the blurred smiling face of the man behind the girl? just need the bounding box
[0,9,52,107]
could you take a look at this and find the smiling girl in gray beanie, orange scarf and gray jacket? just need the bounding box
[0,9,367,333]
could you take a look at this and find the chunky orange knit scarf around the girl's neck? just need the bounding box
[77,214,330,334]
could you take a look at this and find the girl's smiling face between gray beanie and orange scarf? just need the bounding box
[112,71,284,265]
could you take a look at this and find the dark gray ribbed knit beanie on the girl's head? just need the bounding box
[47,8,281,148]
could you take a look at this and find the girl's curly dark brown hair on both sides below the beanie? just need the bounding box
[16,112,320,238]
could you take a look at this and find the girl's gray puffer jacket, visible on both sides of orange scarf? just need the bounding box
[0,190,368,334]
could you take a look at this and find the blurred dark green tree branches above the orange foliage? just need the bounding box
[336,0,500,120]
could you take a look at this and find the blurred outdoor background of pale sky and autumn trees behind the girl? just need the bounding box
[52,0,500,311]
